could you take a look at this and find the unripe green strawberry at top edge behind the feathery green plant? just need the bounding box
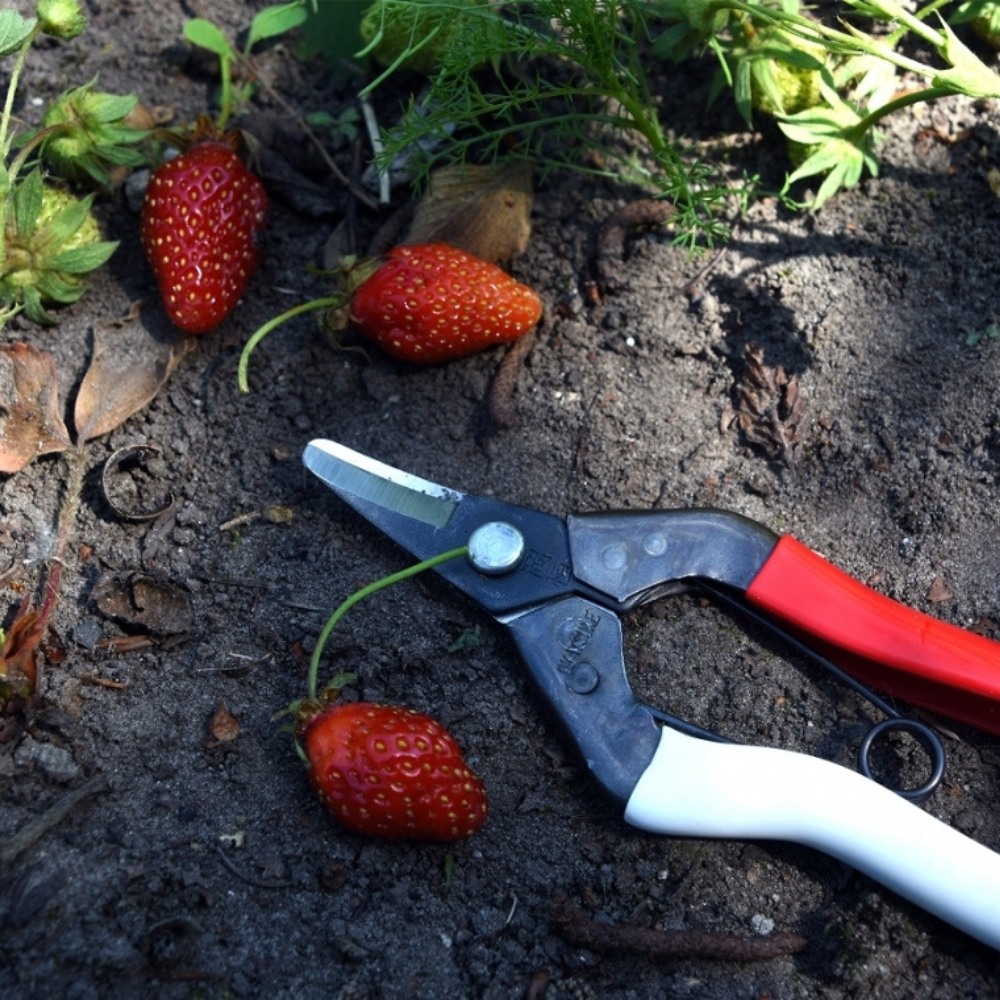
[361,0,496,76]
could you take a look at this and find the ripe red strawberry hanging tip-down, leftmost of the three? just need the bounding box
[141,139,267,333]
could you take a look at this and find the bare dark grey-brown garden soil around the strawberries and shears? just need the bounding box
[0,0,1000,1000]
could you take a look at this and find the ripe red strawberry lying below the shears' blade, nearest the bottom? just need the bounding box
[296,702,486,840]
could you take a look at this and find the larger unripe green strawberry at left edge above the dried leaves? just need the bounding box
[0,170,118,323]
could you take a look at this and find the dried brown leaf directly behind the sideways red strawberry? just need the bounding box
[406,163,534,264]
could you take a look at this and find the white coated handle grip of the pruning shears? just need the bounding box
[625,728,1000,950]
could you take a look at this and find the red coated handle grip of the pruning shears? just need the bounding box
[746,535,1000,735]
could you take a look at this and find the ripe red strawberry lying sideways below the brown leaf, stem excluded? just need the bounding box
[351,243,542,364]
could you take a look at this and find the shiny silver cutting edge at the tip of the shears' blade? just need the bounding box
[302,439,465,528]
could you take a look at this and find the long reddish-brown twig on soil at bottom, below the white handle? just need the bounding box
[549,898,809,962]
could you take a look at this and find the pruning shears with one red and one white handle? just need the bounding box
[303,440,1000,950]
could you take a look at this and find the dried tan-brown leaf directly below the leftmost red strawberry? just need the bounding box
[73,303,191,444]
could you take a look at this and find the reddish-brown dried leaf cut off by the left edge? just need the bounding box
[0,343,72,472]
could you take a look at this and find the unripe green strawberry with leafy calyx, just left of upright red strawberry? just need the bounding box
[42,77,146,185]
